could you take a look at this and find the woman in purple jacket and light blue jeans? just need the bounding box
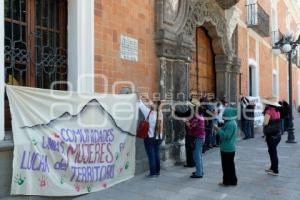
[186,100,205,178]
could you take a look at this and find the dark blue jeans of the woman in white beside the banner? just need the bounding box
[144,137,160,175]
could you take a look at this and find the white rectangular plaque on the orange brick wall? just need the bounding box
[120,35,139,62]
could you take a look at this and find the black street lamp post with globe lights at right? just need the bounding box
[272,31,300,143]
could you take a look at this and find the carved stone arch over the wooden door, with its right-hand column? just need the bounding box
[176,0,240,102]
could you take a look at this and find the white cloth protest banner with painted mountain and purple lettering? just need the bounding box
[6,86,137,196]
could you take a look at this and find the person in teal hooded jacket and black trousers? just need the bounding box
[215,108,237,186]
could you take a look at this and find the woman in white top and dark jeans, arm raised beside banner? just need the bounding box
[138,97,163,178]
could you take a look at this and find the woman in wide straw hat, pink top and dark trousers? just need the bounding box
[262,97,281,176]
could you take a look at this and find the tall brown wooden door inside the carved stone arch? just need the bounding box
[190,27,216,98]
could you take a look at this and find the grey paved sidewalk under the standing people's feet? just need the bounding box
[76,118,300,200]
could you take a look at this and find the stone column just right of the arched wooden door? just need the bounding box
[215,55,232,101]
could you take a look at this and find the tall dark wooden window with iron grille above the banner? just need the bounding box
[4,0,68,129]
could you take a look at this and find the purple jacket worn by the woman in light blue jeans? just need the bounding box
[188,116,205,139]
